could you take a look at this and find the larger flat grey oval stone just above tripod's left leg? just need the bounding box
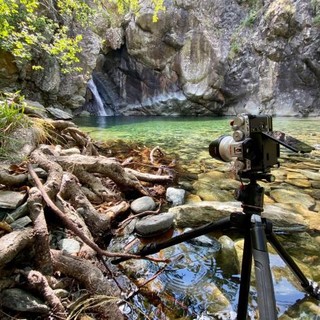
[135,212,174,237]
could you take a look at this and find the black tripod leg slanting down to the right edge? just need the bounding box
[267,232,320,300]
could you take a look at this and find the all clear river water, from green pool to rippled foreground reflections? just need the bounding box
[75,117,320,320]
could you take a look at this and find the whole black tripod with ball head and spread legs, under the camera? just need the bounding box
[113,174,320,320]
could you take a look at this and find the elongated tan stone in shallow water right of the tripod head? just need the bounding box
[270,189,316,209]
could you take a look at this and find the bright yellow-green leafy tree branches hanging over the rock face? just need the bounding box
[0,0,164,73]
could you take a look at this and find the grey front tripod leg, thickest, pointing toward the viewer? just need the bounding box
[250,214,277,320]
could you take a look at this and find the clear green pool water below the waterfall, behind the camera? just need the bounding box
[75,117,320,172]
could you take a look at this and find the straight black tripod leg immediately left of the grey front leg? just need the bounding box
[237,232,252,320]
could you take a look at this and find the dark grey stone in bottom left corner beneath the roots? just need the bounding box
[0,288,50,313]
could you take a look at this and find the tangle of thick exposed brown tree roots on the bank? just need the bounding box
[0,121,178,319]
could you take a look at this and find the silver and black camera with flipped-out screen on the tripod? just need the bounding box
[209,114,314,176]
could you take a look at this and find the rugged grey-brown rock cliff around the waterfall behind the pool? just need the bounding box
[0,0,320,116]
